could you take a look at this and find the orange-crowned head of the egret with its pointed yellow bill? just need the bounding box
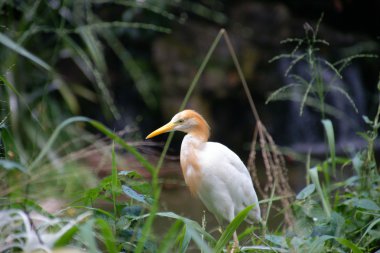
[146,110,210,140]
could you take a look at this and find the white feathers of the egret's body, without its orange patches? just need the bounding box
[181,135,261,224]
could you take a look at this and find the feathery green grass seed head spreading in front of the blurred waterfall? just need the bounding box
[266,15,377,119]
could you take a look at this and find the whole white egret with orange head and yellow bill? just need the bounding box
[147,110,261,232]
